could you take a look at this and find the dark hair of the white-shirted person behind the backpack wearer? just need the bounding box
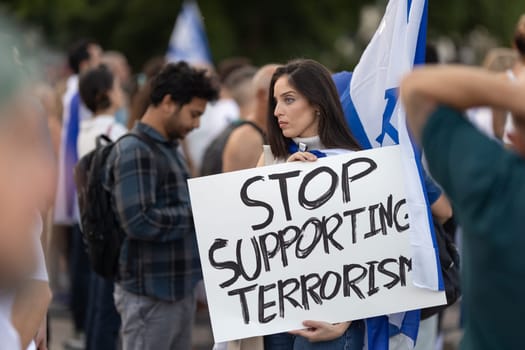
[78,64,115,113]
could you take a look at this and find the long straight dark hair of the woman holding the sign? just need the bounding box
[267,59,361,158]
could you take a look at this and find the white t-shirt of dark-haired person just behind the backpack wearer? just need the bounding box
[77,115,128,159]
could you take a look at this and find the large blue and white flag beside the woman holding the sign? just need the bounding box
[341,0,444,350]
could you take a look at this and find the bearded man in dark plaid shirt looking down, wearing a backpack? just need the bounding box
[104,62,218,350]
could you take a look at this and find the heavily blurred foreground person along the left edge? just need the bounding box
[0,35,55,350]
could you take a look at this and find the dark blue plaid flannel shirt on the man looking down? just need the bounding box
[104,123,202,301]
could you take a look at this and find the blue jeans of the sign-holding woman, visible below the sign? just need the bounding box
[290,320,365,350]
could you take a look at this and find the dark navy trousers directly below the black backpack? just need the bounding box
[86,272,120,350]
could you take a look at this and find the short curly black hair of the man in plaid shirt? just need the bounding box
[150,61,219,106]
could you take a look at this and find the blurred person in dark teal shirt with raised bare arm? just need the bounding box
[401,66,525,350]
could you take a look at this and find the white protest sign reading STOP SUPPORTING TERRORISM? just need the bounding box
[189,146,446,342]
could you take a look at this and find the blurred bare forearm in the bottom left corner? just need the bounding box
[11,280,51,349]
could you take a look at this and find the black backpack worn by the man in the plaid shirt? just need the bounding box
[74,132,158,279]
